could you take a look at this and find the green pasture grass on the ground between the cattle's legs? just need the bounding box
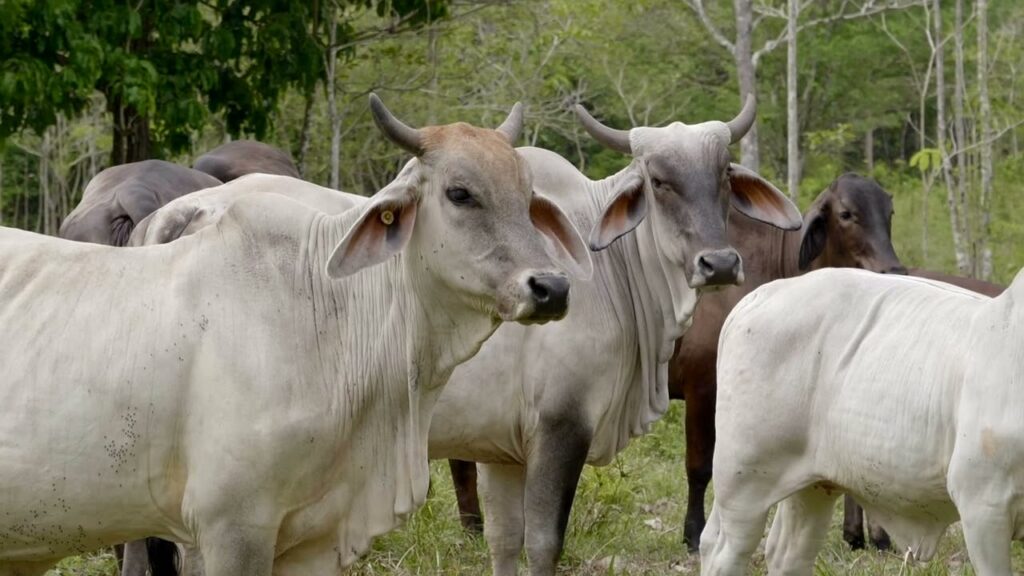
[41,402,1024,576]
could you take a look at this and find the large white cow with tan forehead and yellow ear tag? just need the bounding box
[0,97,590,576]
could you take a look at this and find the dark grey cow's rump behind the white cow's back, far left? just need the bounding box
[58,160,221,246]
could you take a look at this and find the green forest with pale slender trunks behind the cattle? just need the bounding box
[8,0,1024,283]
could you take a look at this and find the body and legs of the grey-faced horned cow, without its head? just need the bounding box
[429,126,799,576]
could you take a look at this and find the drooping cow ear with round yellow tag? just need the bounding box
[327,178,417,278]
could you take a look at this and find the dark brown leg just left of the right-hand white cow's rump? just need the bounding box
[683,374,715,553]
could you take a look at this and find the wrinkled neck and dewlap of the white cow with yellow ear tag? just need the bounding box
[299,207,497,562]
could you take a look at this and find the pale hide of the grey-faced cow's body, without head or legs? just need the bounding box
[430,148,697,464]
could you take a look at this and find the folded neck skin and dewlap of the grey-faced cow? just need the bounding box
[590,168,697,455]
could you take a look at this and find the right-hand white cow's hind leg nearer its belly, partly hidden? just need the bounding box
[765,487,837,576]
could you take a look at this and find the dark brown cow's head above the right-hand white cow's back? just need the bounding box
[800,173,906,274]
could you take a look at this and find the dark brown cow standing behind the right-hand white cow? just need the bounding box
[451,170,906,537]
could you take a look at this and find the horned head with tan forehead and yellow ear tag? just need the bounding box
[328,94,592,323]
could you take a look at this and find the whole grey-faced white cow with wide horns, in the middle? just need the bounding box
[429,99,801,576]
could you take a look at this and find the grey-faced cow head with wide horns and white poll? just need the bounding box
[577,97,801,288]
